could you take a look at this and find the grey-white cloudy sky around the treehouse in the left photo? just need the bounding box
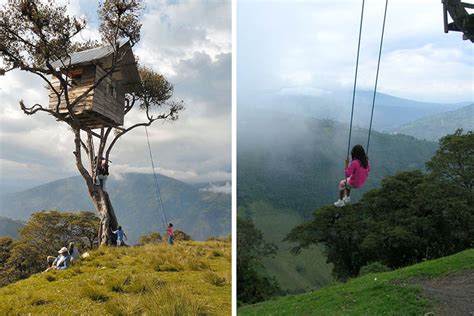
[0,0,232,193]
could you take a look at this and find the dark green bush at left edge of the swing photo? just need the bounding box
[237,217,279,303]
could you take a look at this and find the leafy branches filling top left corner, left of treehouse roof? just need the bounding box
[0,1,86,69]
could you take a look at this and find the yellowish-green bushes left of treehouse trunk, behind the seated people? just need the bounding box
[0,211,99,285]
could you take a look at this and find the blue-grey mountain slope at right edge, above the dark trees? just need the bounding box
[393,103,474,141]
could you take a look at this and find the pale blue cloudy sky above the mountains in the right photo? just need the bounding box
[236,0,474,105]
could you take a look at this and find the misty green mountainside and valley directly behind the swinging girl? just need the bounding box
[237,110,437,293]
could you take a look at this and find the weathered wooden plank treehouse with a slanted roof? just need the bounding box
[49,42,140,128]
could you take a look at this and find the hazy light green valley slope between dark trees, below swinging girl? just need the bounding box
[249,201,333,293]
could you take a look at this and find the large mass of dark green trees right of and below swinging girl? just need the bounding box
[287,131,474,280]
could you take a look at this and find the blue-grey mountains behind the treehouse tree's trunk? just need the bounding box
[0,173,231,243]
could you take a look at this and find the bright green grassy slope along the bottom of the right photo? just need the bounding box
[238,249,474,315]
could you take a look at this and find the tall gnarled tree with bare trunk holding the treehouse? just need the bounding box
[0,0,184,244]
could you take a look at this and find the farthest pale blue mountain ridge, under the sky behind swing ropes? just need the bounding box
[238,91,469,131]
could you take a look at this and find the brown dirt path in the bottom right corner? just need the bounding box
[414,270,474,316]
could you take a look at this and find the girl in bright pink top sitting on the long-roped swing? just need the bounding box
[334,145,370,207]
